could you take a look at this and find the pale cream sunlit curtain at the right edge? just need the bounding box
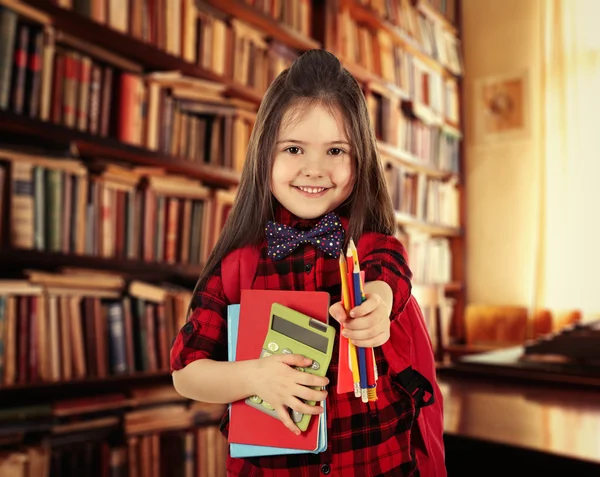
[535,0,600,320]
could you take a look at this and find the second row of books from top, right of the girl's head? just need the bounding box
[340,11,459,125]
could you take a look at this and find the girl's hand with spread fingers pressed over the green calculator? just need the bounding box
[254,354,329,435]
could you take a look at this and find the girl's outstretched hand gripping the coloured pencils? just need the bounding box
[329,293,391,348]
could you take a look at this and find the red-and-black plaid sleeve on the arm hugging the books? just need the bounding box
[171,266,227,372]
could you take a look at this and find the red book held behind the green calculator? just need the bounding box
[229,290,330,451]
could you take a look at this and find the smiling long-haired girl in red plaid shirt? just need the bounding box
[171,50,446,477]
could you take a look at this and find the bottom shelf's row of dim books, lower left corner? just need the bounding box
[0,385,227,477]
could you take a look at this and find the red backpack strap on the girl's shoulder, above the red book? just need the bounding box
[221,245,260,304]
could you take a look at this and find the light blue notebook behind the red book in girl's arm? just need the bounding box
[227,305,327,458]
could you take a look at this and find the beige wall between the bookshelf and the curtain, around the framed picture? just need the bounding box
[461,0,543,306]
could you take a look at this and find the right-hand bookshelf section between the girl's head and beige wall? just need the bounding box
[324,0,467,356]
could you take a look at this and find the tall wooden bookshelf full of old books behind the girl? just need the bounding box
[0,0,466,477]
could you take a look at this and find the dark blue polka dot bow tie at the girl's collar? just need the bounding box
[266,212,344,260]
